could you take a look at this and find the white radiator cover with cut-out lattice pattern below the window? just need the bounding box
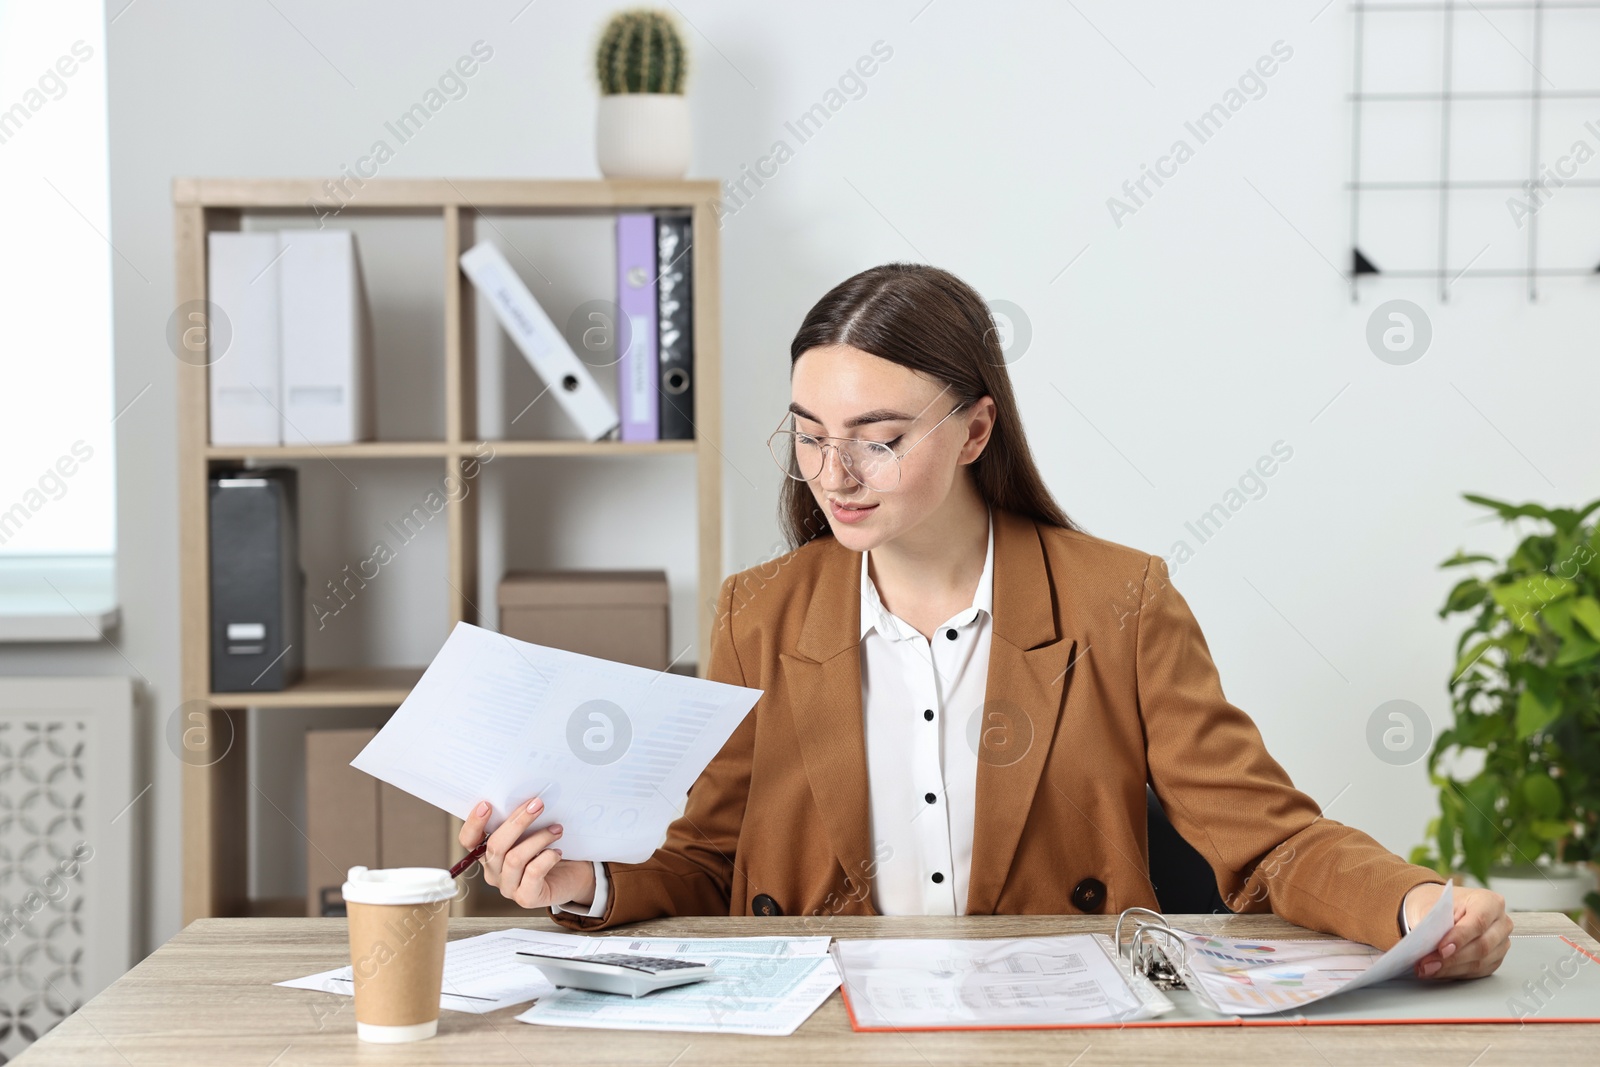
[0,678,136,1062]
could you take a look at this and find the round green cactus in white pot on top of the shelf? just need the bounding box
[595,8,690,178]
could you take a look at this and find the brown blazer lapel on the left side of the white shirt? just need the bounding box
[778,537,874,913]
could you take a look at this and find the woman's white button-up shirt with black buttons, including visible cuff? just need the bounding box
[550,514,995,915]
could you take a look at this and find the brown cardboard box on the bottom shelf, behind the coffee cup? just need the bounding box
[306,728,450,917]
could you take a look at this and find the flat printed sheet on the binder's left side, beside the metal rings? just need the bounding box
[834,934,1173,1030]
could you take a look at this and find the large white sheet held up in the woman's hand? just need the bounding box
[350,622,762,862]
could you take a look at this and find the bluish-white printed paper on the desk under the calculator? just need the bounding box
[517,934,838,1037]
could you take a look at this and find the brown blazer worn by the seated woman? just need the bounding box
[554,509,1442,949]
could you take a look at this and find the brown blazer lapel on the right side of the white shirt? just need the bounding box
[966,507,1077,915]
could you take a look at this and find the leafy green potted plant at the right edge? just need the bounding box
[1411,493,1600,921]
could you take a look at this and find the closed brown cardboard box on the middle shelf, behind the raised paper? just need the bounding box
[499,571,672,670]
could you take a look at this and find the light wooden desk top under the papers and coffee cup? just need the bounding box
[14,912,1600,1067]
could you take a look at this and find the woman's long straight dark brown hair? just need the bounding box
[778,262,1082,549]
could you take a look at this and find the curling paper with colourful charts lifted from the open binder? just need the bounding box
[1179,881,1456,1016]
